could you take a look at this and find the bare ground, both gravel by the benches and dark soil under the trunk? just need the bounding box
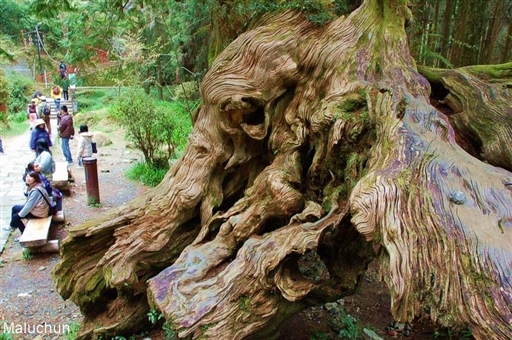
[0,125,462,340]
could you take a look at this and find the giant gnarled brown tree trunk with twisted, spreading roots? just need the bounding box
[54,1,512,339]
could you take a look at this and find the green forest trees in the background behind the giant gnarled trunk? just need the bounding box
[0,0,512,103]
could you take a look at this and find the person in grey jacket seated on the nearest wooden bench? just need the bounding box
[4,171,50,242]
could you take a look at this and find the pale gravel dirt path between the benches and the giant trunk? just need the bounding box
[0,125,147,340]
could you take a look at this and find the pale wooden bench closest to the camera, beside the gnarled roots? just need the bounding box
[19,211,65,248]
